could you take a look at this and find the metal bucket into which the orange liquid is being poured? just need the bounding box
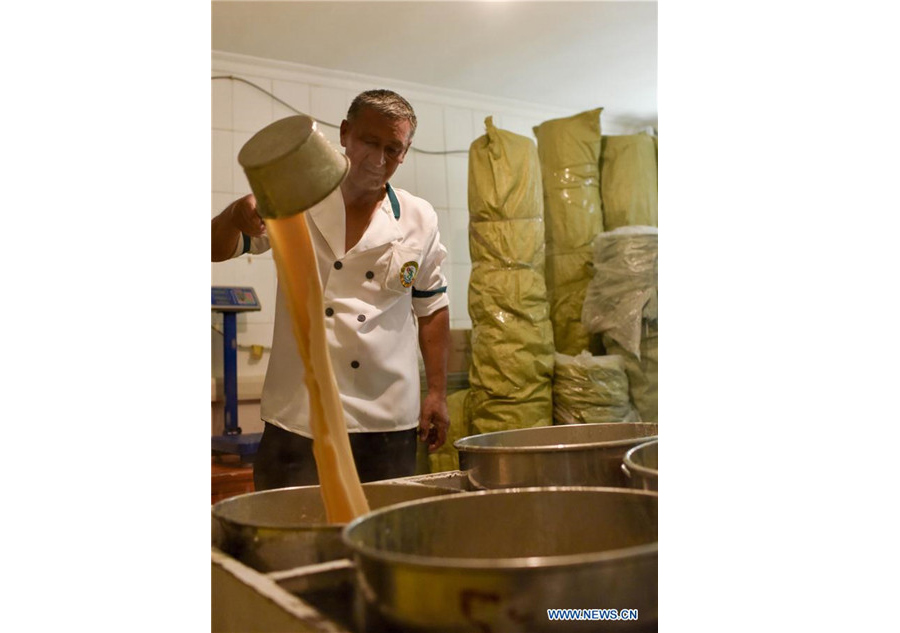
[212,483,454,572]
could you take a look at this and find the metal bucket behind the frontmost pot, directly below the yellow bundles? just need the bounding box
[453,422,657,490]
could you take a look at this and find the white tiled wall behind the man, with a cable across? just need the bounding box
[211,52,636,392]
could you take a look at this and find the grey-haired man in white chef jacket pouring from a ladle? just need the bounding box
[212,90,450,490]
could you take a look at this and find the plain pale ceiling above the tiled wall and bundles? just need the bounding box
[211,0,657,126]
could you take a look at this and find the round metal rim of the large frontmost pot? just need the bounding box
[341,486,659,572]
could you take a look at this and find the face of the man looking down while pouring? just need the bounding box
[341,108,412,190]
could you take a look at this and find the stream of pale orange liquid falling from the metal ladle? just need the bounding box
[265,213,369,523]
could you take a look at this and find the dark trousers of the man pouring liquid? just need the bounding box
[253,422,416,490]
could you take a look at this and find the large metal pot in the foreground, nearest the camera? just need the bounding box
[343,488,657,633]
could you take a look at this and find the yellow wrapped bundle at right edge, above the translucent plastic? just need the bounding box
[600,134,658,231]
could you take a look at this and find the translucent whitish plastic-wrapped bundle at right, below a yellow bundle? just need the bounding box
[581,226,659,358]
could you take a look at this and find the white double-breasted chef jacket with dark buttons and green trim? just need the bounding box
[233,186,449,437]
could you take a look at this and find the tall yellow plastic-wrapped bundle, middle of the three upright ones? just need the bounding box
[534,108,603,355]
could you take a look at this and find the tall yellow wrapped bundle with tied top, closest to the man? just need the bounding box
[465,117,553,433]
